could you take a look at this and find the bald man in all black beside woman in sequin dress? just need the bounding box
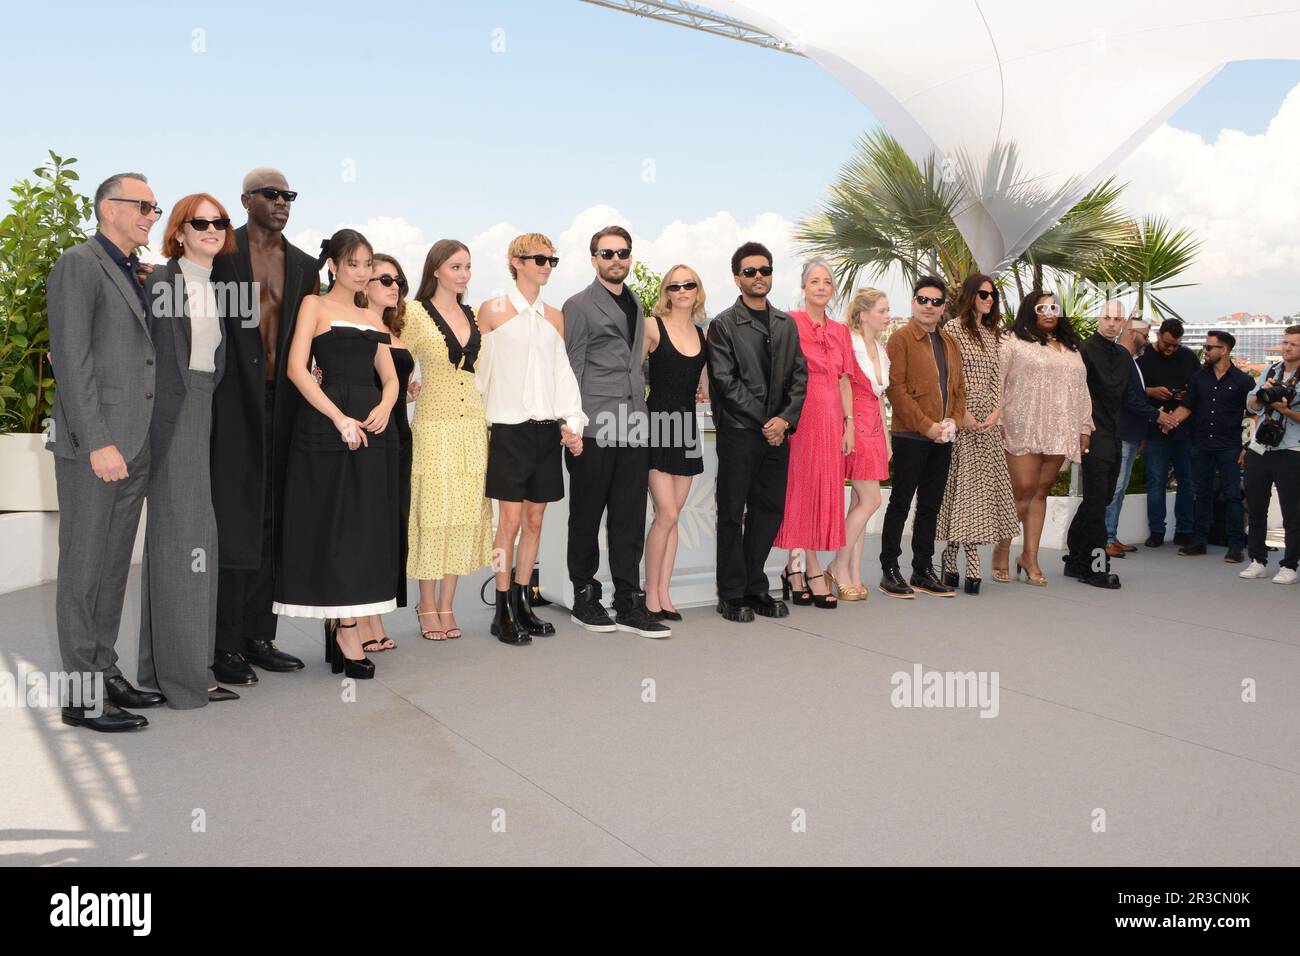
[1063,302,1134,591]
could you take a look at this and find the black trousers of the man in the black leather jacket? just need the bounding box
[716,428,790,601]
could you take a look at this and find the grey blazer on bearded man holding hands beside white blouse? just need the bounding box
[563,280,649,445]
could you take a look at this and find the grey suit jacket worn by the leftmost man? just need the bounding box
[46,237,157,462]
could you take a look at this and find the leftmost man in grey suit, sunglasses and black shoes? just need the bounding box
[46,173,163,731]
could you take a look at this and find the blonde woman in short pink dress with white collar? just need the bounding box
[829,289,892,601]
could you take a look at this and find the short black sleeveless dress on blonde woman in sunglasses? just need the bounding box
[646,316,707,476]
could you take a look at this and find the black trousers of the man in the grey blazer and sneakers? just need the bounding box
[564,441,650,604]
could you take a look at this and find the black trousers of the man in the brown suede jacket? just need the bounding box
[880,437,953,574]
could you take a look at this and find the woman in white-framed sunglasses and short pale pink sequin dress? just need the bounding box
[1002,291,1092,588]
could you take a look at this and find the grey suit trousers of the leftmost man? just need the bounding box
[55,442,150,678]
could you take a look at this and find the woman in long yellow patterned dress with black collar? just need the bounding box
[402,239,493,641]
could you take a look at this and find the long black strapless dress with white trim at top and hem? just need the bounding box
[273,323,399,618]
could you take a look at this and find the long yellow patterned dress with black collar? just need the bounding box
[402,300,493,580]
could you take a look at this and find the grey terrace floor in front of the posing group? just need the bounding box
[0,538,1300,866]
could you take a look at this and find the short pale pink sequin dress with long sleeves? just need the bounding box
[1002,334,1092,462]
